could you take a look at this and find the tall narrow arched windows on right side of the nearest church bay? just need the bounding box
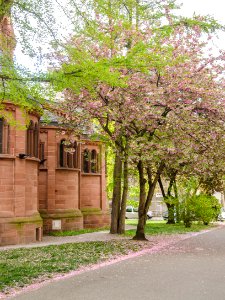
[26,121,39,157]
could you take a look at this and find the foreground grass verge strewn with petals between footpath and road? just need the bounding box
[0,240,144,293]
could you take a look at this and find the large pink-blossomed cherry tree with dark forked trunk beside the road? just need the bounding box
[46,1,224,239]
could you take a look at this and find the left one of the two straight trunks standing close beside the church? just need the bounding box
[110,153,122,234]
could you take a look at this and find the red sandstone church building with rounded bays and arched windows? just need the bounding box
[0,103,109,245]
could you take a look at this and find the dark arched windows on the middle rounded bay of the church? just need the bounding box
[59,140,77,168]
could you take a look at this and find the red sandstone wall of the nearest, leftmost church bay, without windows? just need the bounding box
[0,104,42,245]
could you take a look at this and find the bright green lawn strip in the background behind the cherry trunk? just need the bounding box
[125,220,214,236]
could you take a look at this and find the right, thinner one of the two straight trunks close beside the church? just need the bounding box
[118,155,129,234]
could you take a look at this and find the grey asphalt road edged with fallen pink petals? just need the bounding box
[11,226,225,300]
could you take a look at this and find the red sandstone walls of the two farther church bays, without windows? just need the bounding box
[39,126,109,232]
